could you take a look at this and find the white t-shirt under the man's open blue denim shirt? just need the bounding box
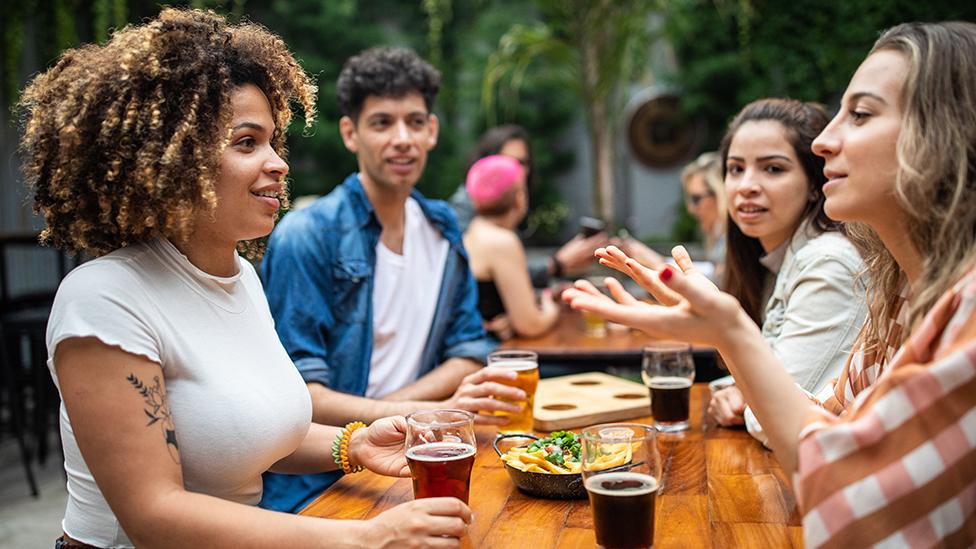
[366,198,449,398]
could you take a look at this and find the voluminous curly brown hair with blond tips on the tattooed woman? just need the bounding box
[18,9,316,257]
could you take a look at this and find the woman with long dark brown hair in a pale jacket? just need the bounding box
[597,99,865,432]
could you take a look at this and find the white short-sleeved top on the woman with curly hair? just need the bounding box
[47,239,312,547]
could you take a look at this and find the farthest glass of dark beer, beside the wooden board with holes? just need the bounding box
[641,341,695,432]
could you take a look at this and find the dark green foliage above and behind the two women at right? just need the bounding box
[661,0,976,149]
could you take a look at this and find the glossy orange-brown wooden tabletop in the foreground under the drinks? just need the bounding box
[301,384,803,549]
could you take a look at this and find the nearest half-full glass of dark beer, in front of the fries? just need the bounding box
[581,424,661,549]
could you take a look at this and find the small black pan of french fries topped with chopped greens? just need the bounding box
[492,431,630,499]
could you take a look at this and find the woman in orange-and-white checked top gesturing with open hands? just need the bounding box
[565,22,976,547]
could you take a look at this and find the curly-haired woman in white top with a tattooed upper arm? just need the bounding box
[21,9,471,547]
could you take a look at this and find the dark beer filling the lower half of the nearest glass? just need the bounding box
[585,471,657,549]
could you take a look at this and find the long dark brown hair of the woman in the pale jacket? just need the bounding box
[719,99,840,324]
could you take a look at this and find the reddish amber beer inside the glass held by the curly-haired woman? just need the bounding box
[407,442,475,503]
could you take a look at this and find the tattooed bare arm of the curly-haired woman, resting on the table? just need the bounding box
[55,337,470,548]
